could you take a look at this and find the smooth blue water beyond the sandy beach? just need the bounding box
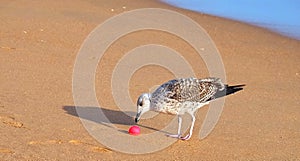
[163,0,300,40]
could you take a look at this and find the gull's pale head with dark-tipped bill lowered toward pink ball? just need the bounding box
[135,93,150,122]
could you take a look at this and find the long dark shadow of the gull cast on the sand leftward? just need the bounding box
[63,106,169,134]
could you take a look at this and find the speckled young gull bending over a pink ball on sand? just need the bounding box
[135,77,245,140]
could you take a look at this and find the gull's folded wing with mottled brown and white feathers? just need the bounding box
[161,78,224,102]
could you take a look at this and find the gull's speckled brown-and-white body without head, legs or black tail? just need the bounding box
[150,78,224,114]
